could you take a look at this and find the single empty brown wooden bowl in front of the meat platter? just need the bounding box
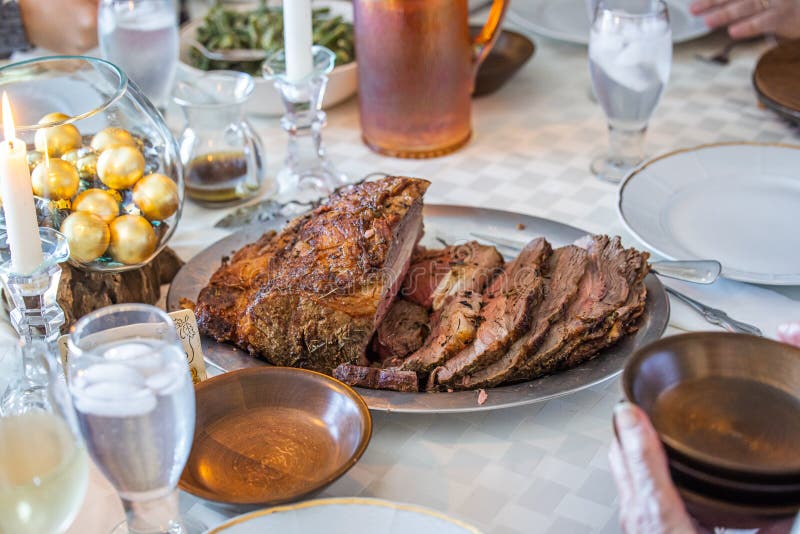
[179,367,372,507]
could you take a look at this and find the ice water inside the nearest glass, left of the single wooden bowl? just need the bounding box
[71,340,195,501]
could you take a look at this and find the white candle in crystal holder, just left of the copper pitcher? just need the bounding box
[283,0,313,83]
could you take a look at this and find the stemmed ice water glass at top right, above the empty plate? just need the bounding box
[589,0,672,182]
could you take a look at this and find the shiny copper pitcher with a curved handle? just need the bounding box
[353,0,508,158]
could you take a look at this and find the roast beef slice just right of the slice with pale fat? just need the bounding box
[428,238,552,388]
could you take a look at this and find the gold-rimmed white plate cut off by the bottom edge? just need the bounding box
[208,498,480,534]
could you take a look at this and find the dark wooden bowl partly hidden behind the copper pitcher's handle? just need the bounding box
[469,26,536,96]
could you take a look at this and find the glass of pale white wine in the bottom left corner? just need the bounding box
[0,341,89,534]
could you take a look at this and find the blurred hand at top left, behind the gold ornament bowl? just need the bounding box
[19,0,98,54]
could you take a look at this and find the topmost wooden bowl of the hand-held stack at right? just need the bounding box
[622,332,800,484]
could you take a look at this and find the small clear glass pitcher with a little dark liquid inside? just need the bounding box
[173,71,265,207]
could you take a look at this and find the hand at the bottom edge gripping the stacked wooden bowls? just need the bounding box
[608,402,696,534]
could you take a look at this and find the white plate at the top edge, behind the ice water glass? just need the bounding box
[508,0,710,44]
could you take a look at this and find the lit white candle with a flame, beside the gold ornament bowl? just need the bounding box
[0,93,42,274]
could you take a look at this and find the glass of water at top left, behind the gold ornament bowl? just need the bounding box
[97,0,178,110]
